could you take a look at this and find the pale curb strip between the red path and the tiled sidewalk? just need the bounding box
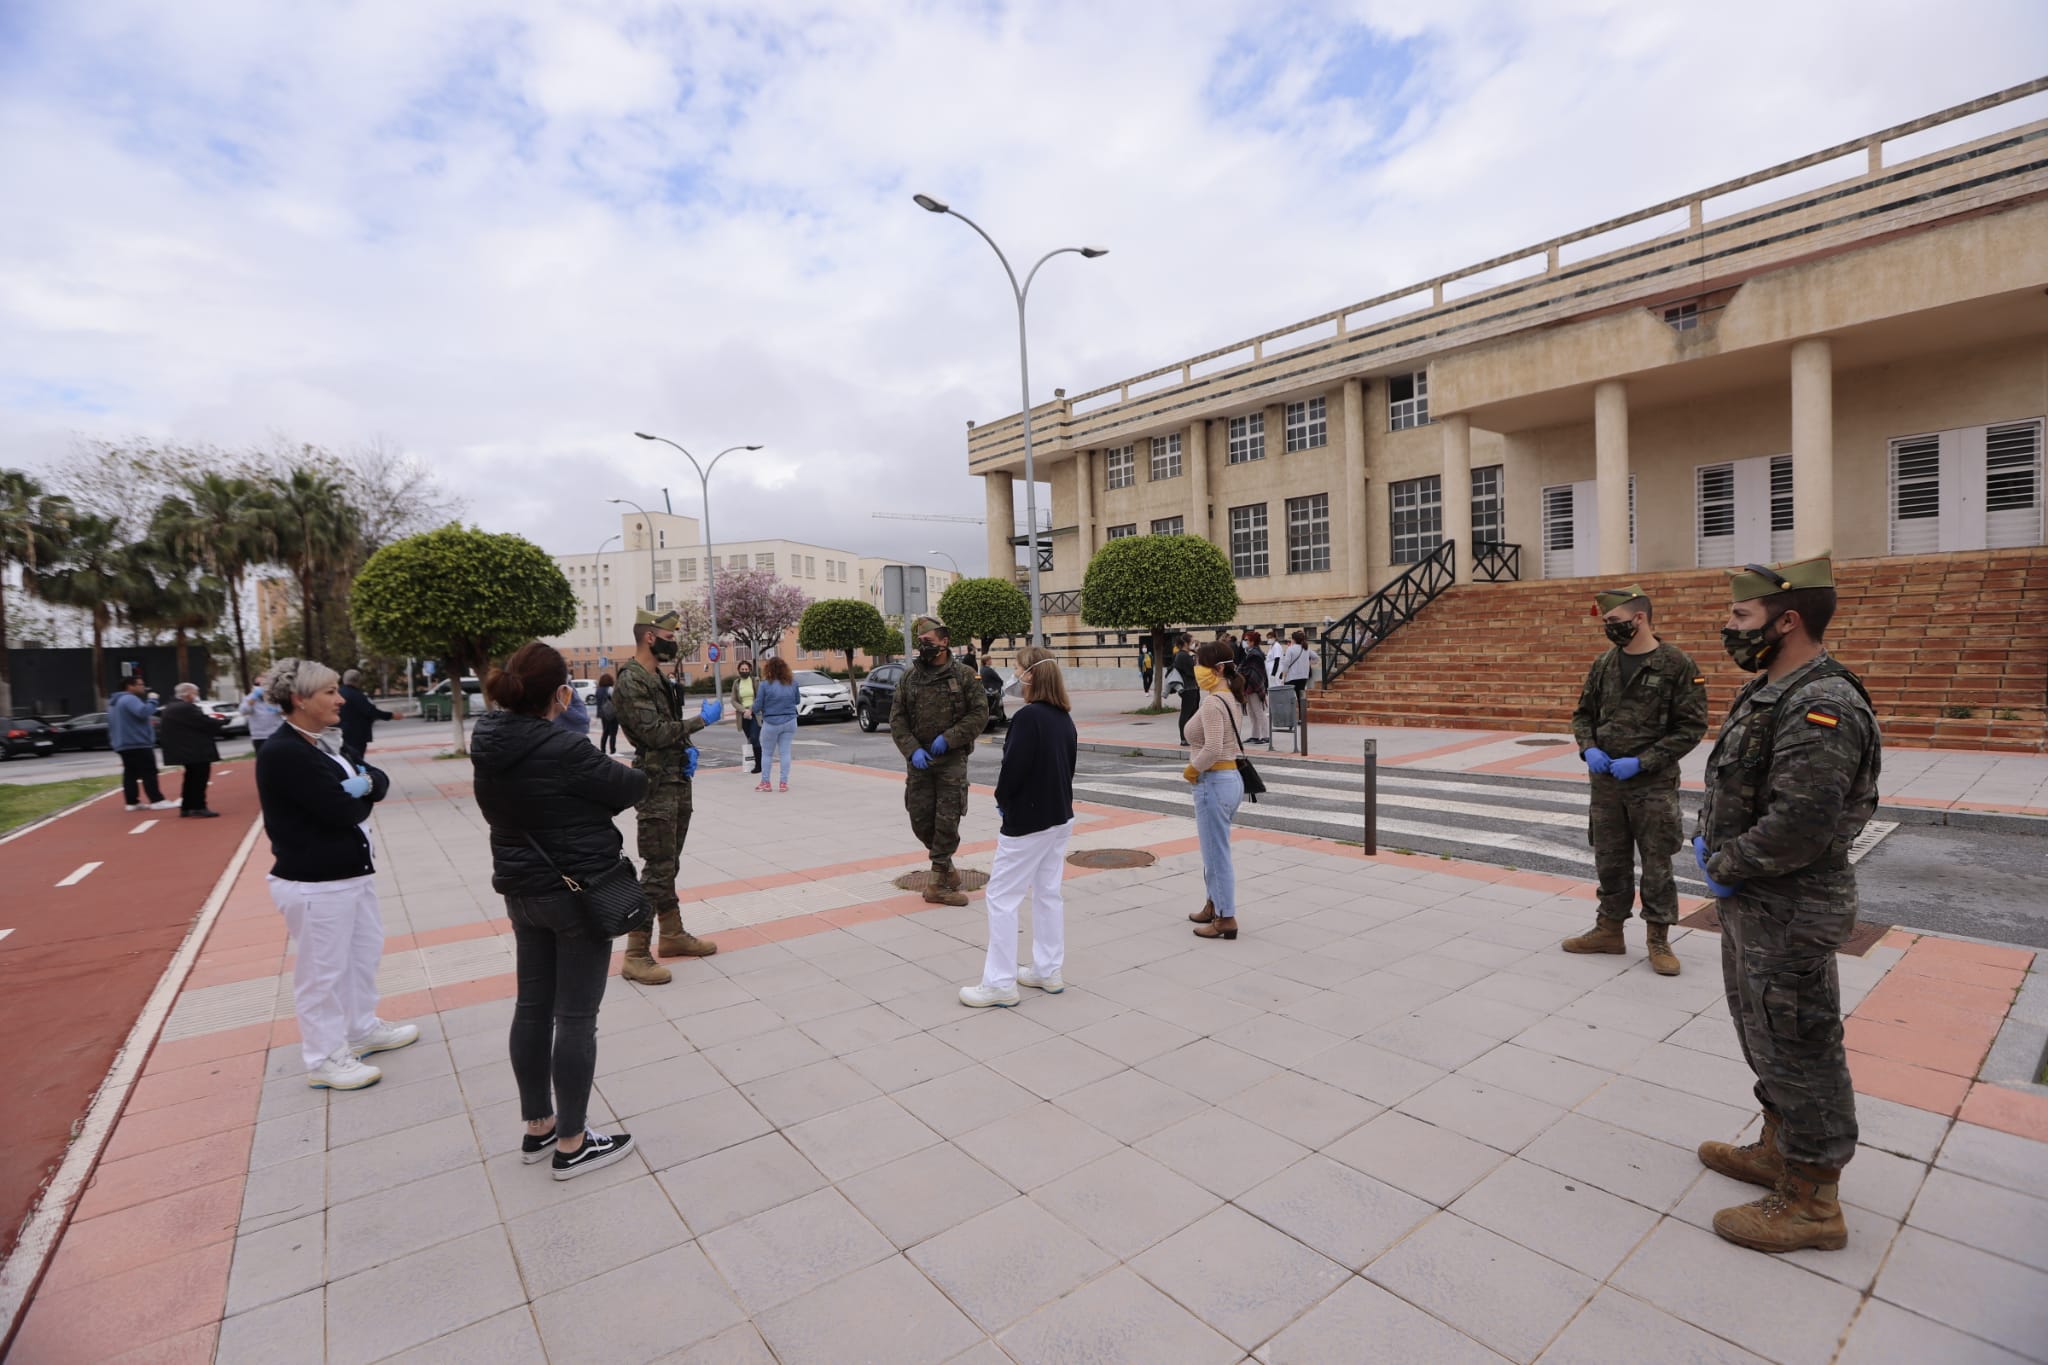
[0,818,262,1357]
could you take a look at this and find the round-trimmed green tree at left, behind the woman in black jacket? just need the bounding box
[348,524,575,753]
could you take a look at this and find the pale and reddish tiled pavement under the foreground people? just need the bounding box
[8,743,2048,1365]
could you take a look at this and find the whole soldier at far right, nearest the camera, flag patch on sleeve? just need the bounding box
[1692,555,1882,1250]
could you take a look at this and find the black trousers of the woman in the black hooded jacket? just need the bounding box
[506,894,612,1134]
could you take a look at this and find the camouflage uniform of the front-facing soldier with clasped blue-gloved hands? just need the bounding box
[1571,643,1706,925]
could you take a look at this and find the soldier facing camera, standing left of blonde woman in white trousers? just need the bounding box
[889,616,989,905]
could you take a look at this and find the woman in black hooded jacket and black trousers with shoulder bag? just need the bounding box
[469,641,647,1181]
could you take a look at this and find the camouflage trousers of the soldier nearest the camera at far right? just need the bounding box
[1720,868,1855,1166]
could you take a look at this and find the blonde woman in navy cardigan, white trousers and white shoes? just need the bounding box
[961,645,1079,1009]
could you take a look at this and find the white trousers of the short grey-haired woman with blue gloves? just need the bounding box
[270,876,383,1070]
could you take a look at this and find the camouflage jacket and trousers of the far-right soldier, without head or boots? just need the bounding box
[1700,651,1882,1169]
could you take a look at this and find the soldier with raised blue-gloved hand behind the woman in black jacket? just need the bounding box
[612,610,725,986]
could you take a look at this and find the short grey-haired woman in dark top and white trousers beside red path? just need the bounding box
[256,659,420,1091]
